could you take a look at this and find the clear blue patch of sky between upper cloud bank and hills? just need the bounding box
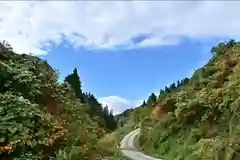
[41,38,219,111]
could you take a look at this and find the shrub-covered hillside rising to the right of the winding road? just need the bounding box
[120,40,240,160]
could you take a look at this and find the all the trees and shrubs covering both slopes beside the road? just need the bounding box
[0,40,240,160]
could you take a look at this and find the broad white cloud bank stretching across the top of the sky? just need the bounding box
[0,1,240,54]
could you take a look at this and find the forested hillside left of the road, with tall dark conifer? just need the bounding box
[0,41,117,160]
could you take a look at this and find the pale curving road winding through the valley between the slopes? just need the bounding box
[120,129,163,160]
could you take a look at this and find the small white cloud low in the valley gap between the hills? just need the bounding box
[98,96,142,115]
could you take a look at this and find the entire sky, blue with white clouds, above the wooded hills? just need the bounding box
[0,1,240,114]
